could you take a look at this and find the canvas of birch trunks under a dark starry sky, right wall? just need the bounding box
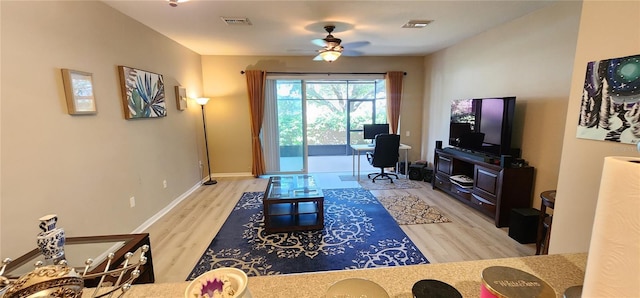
[576,55,640,144]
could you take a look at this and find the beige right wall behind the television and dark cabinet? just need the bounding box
[423,1,580,212]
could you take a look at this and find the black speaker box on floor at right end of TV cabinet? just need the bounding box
[509,208,540,244]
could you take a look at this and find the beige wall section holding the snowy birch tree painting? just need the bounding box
[549,1,640,253]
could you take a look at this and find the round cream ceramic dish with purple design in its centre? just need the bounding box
[184,268,251,298]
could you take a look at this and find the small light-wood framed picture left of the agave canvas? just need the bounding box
[62,69,98,115]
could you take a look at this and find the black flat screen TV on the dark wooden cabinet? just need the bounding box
[449,97,516,156]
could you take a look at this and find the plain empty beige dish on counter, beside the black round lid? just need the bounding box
[326,278,389,298]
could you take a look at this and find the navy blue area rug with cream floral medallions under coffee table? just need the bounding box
[187,188,429,280]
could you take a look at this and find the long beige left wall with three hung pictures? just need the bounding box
[0,1,202,257]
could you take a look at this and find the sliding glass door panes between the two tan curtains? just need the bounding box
[262,79,387,174]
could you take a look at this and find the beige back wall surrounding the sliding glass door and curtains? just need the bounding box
[202,56,424,175]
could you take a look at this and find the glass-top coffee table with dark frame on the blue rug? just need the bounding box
[262,175,324,233]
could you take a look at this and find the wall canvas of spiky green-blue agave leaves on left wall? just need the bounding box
[118,66,167,119]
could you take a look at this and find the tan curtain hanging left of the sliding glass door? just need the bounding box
[245,70,267,177]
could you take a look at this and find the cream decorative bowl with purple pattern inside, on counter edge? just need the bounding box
[184,268,248,298]
